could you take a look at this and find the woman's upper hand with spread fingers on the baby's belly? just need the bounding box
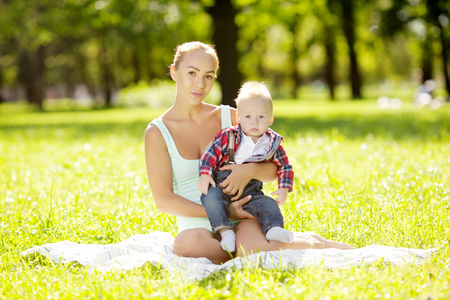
[219,163,255,201]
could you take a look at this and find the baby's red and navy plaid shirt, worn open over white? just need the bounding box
[199,125,294,191]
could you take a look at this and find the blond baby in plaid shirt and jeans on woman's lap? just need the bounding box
[198,82,294,252]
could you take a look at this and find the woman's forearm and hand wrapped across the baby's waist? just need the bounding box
[220,162,278,201]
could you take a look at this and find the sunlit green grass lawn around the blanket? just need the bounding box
[0,101,450,299]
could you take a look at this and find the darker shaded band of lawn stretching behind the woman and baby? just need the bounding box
[0,108,450,141]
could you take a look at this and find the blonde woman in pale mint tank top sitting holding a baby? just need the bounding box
[145,42,352,264]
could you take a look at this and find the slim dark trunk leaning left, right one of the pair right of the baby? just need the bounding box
[341,0,361,99]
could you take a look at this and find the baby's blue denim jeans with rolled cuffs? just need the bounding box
[200,170,284,234]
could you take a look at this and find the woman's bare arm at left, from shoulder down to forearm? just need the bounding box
[144,125,206,218]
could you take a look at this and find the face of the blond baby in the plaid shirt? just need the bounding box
[236,97,273,142]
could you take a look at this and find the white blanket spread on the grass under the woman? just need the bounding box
[22,232,434,280]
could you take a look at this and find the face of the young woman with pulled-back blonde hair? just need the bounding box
[170,50,217,103]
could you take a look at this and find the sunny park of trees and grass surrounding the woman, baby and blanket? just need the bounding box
[0,0,450,299]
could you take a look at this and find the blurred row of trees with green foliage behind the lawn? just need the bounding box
[0,0,450,108]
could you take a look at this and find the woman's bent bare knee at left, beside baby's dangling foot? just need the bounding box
[173,228,231,264]
